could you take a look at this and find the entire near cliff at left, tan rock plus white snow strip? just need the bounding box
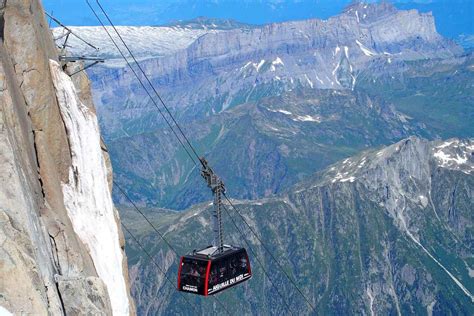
[0,0,134,315]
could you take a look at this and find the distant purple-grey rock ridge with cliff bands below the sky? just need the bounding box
[86,0,462,131]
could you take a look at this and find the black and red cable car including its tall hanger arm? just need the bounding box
[178,158,252,296]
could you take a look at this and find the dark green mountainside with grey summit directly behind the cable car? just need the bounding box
[123,137,474,315]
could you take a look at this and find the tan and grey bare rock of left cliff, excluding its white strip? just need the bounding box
[0,0,134,315]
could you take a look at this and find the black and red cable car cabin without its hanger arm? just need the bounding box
[178,245,252,296]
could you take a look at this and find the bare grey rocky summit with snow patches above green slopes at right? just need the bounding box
[312,136,474,239]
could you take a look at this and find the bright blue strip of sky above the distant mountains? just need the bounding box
[43,0,474,38]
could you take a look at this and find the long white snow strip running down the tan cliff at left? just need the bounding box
[50,60,129,315]
